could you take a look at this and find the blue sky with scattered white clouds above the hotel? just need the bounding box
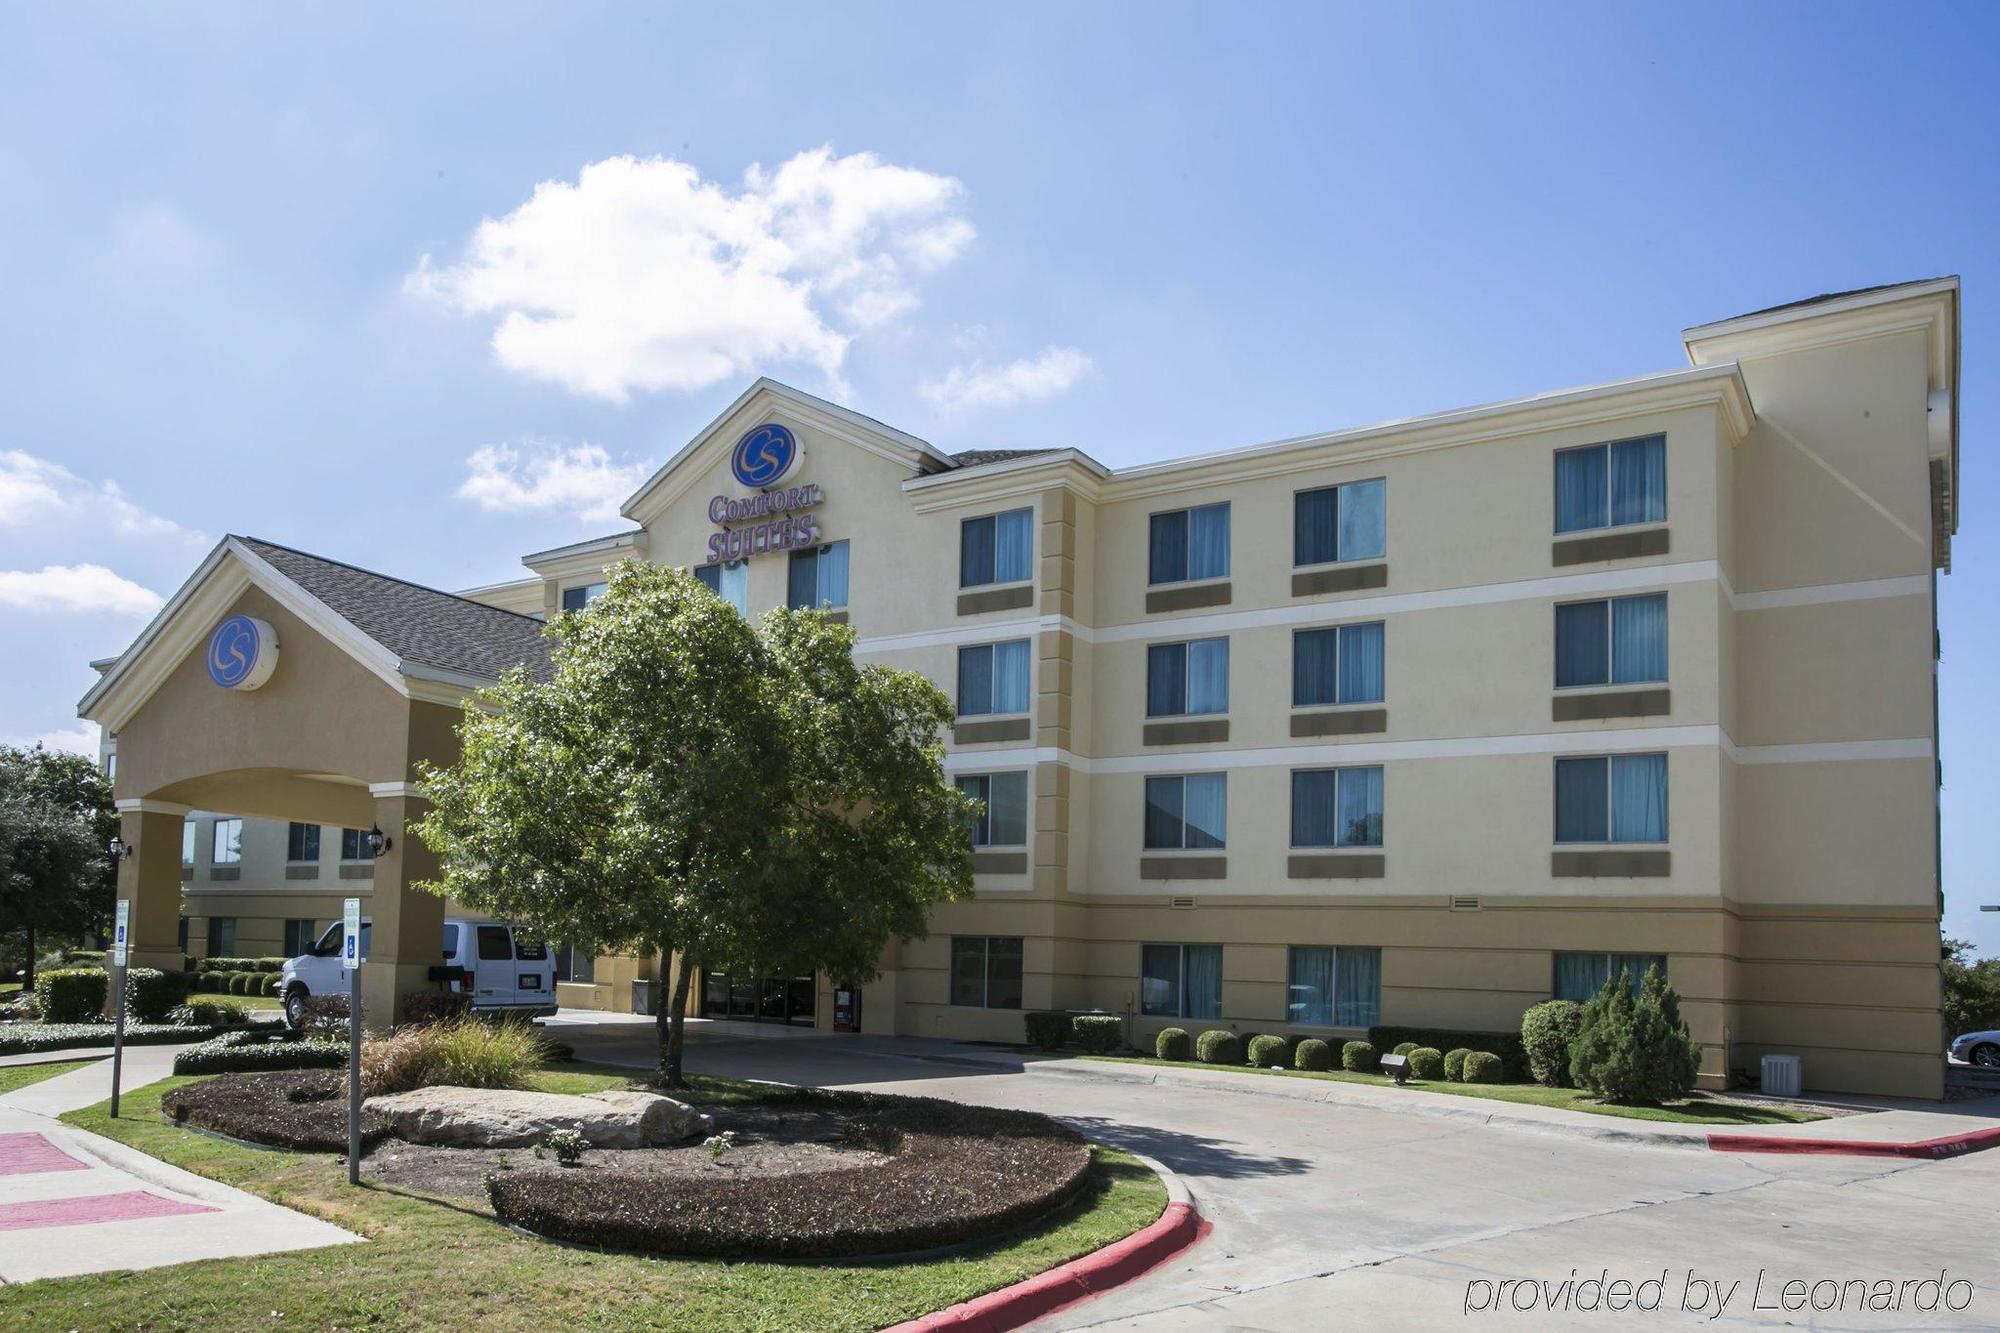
[0,4,2000,953]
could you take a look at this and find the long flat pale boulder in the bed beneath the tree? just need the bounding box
[364,1087,714,1149]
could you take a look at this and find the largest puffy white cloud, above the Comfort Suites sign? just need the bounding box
[406,148,974,402]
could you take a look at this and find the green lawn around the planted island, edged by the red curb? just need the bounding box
[0,1065,1166,1333]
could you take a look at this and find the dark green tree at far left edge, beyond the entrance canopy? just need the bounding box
[0,747,118,985]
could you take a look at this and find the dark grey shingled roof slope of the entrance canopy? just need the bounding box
[236,536,550,681]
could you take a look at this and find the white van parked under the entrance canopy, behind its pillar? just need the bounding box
[278,917,556,1027]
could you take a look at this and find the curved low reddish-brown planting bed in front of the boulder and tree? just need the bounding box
[486,1097,1090,1259]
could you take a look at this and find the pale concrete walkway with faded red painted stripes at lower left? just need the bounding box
[0,1047,362,1283]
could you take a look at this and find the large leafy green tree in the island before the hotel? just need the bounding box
[416,560,974,1085]
